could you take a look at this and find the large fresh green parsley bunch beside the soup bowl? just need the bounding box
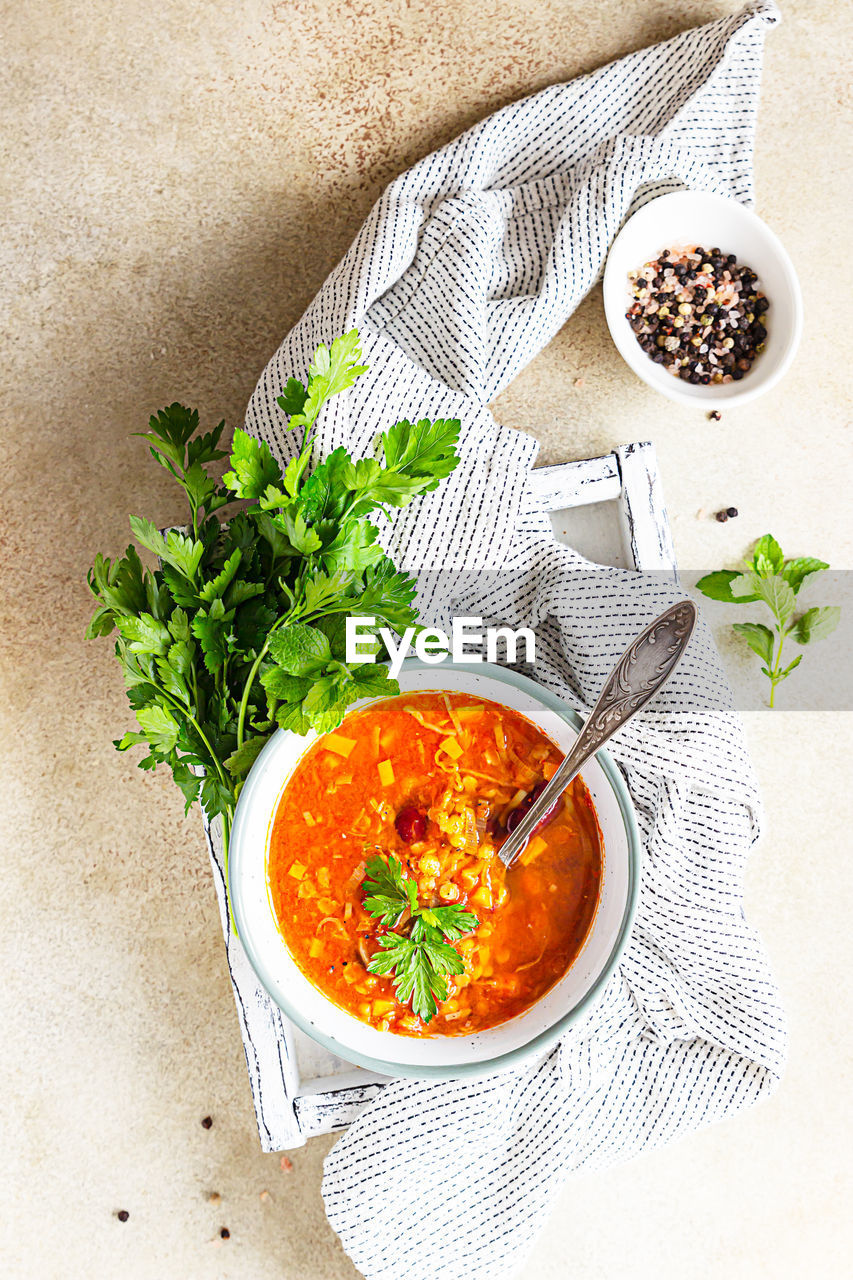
[87,329,460,890]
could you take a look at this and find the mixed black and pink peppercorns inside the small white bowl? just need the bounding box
[626,246,770,387]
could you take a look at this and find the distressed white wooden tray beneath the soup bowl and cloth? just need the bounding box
[206,443,675,1151]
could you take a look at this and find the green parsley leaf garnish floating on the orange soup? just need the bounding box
[362,854,480,1023]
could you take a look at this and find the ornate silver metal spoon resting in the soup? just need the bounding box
[498,600,697,867]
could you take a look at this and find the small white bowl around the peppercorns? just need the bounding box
[605,191,803,410]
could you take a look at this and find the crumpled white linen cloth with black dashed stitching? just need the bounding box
[229,3,785,1280]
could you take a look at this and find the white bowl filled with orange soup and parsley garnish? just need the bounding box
[229,660,640,1078]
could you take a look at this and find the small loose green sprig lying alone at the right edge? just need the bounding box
[695,534,841,707]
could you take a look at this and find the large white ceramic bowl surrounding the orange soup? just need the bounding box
[229,662,640,1078]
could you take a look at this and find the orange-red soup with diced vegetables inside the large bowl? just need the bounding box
[269,692,603,1036]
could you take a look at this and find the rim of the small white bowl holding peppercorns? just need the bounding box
[602,189,803,411]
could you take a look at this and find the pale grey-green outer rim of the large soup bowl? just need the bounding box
[227,658,643,1080]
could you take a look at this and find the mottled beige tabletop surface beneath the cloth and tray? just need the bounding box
[0,0,853,1280]
